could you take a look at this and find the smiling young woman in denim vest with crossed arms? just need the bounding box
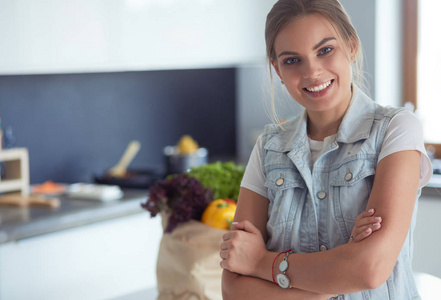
[220,0,432,300]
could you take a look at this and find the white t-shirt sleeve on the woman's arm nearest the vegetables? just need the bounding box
[240,136,268,198]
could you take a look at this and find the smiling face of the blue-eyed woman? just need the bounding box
[272,14,356,115]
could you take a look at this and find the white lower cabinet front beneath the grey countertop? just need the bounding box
[0,213,162,300]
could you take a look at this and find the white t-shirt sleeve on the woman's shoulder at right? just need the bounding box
[378,110,432,188]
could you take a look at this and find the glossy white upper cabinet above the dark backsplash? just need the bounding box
[0,0,275,74]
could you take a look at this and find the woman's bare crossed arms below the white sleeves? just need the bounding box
[221,151,420,299]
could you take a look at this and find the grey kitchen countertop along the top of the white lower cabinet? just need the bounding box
[0,189,148,244]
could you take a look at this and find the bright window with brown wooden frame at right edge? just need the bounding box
[403,0,441,158]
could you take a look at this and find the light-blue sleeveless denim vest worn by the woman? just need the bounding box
[262,87,421,300]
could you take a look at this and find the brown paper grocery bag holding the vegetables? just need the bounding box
[156,215,228,300]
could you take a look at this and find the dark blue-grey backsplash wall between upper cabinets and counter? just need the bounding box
[0,68,236,183]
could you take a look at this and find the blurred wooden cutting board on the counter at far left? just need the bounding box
[0,193,60,208]
